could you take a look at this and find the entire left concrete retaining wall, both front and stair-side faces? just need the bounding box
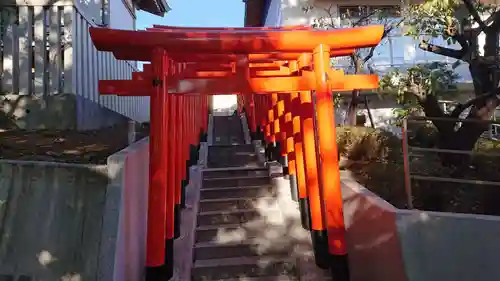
[0,139,149,281]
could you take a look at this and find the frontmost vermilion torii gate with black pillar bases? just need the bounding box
[90,26,384,280]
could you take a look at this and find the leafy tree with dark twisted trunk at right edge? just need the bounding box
[381,0,500,160]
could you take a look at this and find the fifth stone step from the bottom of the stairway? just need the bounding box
[200,197,277,212]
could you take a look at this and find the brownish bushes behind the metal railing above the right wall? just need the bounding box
[337,126,500,215]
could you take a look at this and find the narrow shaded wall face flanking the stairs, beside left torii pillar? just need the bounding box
[98,138,149,281]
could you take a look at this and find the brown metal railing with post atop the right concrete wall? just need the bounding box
[402,117,500,213]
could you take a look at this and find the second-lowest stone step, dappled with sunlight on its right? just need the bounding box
[194,239,290,260]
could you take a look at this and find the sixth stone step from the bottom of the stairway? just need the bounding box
[200,184,278,200]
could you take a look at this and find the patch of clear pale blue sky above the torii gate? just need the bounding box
[136,0,245,29]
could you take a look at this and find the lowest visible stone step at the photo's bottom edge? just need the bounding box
[192,256,298,281]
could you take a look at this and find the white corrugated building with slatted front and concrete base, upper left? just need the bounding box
[0,0,169,129]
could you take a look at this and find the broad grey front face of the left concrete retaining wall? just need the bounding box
[0,161,108,280]
